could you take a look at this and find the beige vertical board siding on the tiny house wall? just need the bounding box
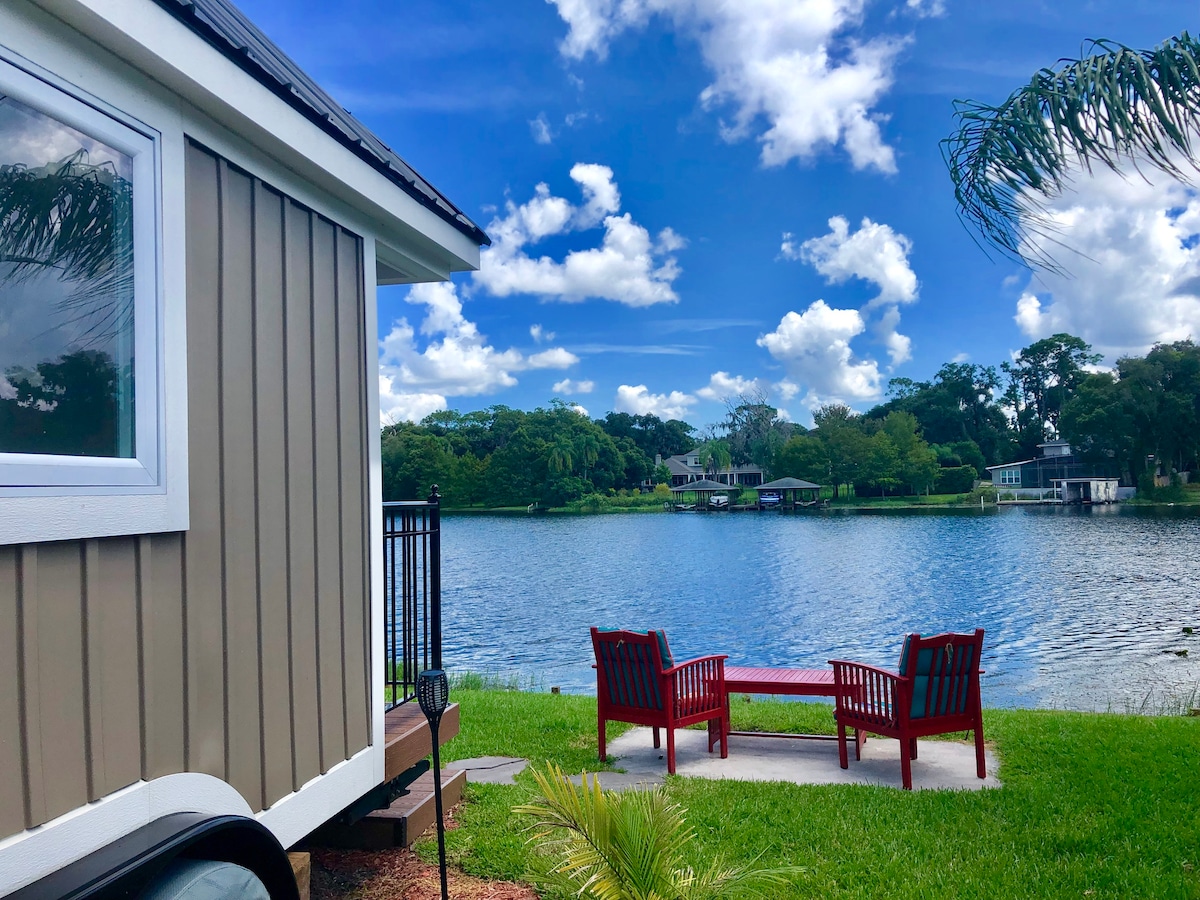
[0,145,372,838]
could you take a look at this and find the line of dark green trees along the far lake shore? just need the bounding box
[383,334,1200,506]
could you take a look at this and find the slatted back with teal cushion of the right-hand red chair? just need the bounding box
[900,629,983,719]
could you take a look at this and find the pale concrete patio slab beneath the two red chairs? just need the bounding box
[600,728,1001,791]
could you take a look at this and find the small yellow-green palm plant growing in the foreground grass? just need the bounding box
[514,764,802,900]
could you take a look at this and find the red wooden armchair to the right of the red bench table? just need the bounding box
[829,628,988,791]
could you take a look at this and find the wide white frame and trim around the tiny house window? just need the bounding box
[0,42,190,546]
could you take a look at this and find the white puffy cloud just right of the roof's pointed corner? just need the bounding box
[474,163,684,306]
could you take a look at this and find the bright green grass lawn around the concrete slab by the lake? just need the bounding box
[418,686,1200,900]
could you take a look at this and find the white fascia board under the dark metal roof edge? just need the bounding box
[34,0,479,277]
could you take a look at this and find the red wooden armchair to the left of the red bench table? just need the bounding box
[592,628,730,774]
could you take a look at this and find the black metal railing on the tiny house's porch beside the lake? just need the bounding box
[383,485,442,709]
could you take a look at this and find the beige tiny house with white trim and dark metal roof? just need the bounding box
[0,0,487,895]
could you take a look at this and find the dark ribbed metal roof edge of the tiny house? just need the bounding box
[155,0,492,246]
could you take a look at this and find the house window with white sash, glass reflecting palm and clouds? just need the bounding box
[0,60,163,496]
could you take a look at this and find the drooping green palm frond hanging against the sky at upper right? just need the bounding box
[942,31,1200,269]
